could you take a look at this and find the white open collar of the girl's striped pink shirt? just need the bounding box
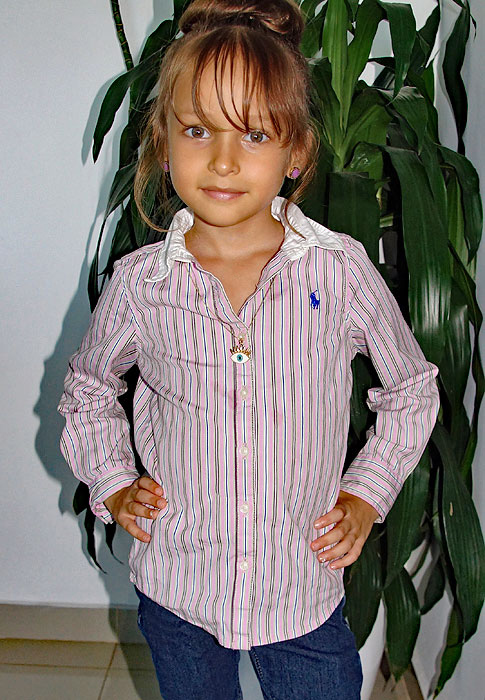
[146,196,344,282]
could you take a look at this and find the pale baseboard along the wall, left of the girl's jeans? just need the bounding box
[0,604,144,643]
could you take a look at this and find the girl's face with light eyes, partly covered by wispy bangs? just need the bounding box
[167,56,303,239]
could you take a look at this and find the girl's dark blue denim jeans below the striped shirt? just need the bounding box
[135,588,362,700]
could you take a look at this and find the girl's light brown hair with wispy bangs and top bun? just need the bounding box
[134,0,319,232]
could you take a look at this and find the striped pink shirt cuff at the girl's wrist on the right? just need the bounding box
[340,456,403,523]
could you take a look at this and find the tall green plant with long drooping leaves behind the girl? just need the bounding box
[75,0,485,696]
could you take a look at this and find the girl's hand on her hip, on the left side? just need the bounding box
[104,476,167,542]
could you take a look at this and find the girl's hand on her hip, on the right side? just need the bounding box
[310,491,379,569]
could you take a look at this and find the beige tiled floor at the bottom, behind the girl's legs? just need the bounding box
[0,639,420,700]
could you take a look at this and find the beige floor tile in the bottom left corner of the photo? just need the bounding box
[0,664,105,700]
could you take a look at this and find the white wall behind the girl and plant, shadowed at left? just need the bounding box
[0,0,485,700]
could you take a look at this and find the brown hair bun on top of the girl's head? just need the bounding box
[179,0,305,48]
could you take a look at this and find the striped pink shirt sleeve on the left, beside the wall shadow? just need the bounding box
[58,263,138,522]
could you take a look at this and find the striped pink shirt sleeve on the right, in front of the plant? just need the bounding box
[340,237,439,522]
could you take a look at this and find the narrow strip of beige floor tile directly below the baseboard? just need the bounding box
[0,639,115,669]
